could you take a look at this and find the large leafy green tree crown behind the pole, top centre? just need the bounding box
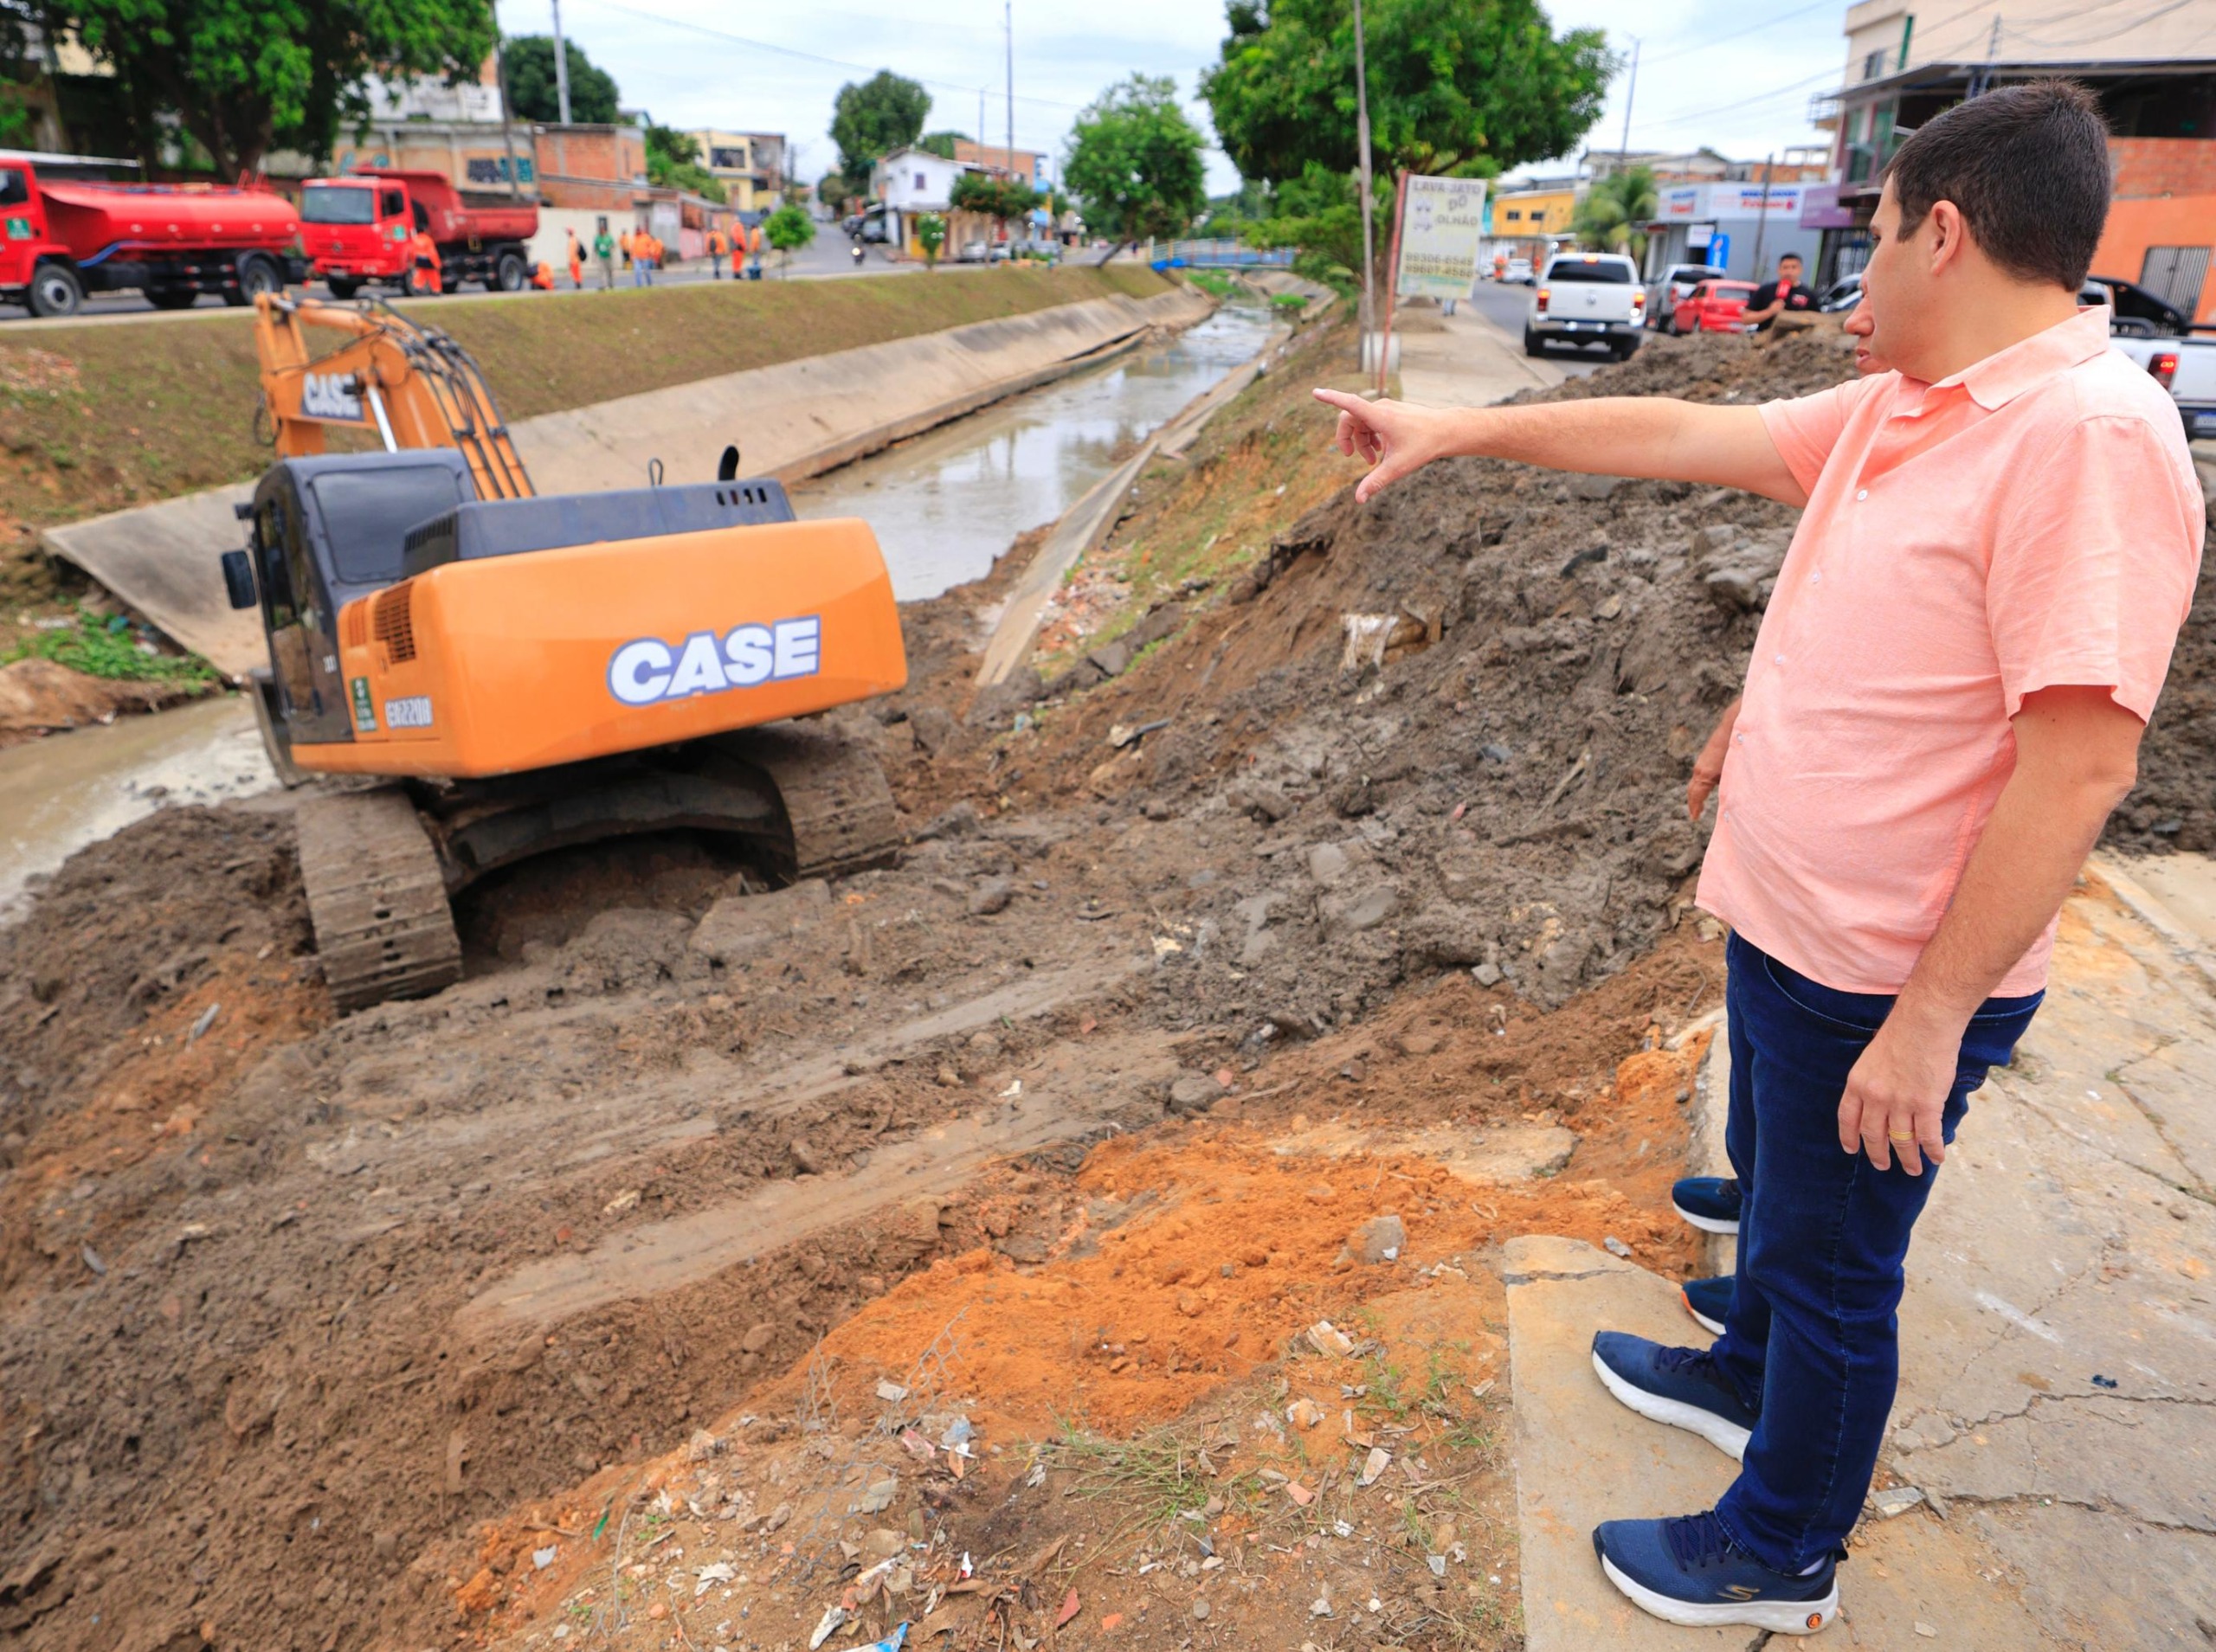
[1201,0,1615,183]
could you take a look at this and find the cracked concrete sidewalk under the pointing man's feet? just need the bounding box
[1509,855,2216,1652]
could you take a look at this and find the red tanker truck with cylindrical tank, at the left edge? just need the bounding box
[0,148,306,317]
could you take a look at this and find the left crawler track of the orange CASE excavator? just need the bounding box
[294,786,461,1010]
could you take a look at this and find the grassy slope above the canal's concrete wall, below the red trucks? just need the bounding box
[0,264,1168,655]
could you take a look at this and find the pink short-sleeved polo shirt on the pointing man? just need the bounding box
[1700,310,2205,997]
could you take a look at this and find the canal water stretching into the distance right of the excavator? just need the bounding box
[791,305,1274,602]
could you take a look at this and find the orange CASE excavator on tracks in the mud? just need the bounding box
[224,294,909,1010]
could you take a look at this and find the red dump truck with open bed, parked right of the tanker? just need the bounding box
[300,166,538,299]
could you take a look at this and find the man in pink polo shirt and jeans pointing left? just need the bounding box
[1317,82,2205,1635]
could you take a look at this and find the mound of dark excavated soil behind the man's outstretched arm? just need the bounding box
[962,334,1851,1038]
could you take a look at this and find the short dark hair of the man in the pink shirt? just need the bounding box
[1886,80,2110,292]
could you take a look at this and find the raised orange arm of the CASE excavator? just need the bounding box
[254,292,537,498]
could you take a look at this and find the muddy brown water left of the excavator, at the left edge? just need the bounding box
[0,693,277,922]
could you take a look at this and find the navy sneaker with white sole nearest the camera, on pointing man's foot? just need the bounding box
[1594,1513,1839,1635]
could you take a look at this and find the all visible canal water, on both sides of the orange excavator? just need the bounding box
[0,305,1274,922]
